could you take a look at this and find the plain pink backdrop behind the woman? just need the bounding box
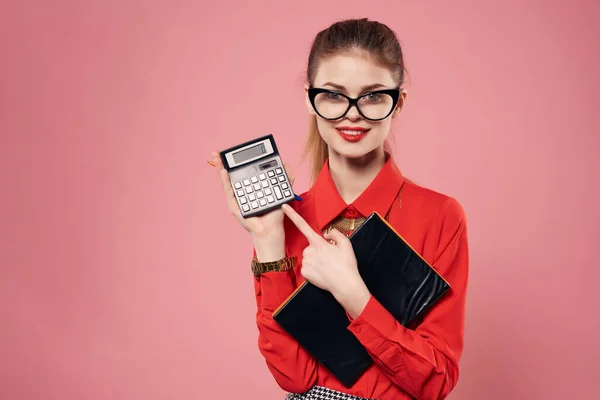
[0,0,600,400]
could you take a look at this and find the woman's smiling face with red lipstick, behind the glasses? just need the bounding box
[306,54,406,158]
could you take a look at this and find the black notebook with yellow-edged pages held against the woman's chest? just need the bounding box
[273,212,450,387]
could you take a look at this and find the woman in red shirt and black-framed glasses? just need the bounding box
[212,19,468,400]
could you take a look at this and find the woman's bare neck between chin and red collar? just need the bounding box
[329,146,386,204]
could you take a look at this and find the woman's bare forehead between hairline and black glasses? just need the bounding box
[313,53,396,92]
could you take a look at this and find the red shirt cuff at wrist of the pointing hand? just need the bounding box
[348,295,406,356]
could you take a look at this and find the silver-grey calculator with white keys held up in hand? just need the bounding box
[220,135,295,218]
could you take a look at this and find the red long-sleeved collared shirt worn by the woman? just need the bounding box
[254,158,468,400]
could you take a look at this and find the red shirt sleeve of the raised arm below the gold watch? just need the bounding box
[254,253,317,393]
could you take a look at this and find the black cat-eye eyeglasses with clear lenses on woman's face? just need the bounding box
[308,88,400,121]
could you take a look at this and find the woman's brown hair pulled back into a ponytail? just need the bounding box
[304,18,405,182]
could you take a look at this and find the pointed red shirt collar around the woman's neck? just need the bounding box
[312,153,404,229]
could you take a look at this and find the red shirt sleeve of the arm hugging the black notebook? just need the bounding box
[348,198,469,399]
